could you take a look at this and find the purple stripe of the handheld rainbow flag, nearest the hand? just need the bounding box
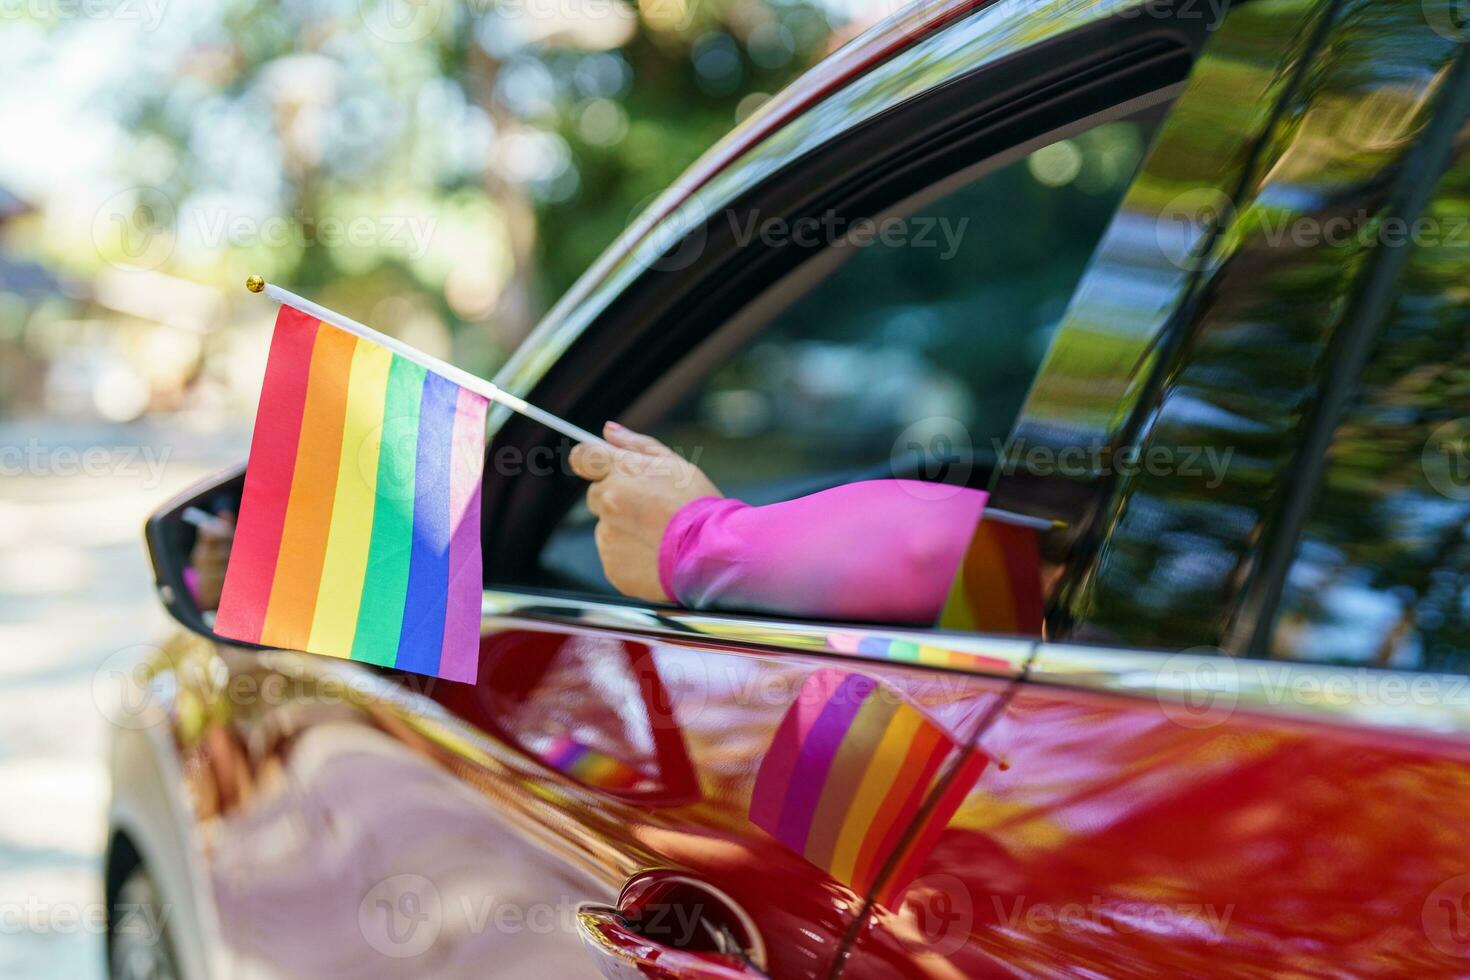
[438,388,490,683]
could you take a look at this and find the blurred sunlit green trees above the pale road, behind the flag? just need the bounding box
[0,0,897,429]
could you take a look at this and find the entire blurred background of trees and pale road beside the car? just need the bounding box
[0,0,892,979]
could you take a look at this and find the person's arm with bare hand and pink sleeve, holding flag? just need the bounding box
[572,425,985,623]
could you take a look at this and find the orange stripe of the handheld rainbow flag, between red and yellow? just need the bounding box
[260,323,357,649]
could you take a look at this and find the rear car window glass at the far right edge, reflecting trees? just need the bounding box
[1270,138,1470,670]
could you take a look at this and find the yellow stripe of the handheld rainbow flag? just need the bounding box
[310,342,392,658]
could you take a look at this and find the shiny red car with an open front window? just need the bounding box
[117,0,1470,979]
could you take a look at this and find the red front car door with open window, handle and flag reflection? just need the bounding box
[149,0,1208,977]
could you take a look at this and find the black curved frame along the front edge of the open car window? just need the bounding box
[484,7,1207,617]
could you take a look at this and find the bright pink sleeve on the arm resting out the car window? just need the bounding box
[659,480,985,623]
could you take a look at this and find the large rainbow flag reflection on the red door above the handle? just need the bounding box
[750,669,979,896]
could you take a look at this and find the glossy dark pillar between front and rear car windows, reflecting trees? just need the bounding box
[944,4,1461,654]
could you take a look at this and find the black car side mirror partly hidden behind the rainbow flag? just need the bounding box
[144,464,245,638]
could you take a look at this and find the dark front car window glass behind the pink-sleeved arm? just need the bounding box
[541,107,1164,591]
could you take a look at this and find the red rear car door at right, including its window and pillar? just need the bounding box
[853,1,1470,977]
